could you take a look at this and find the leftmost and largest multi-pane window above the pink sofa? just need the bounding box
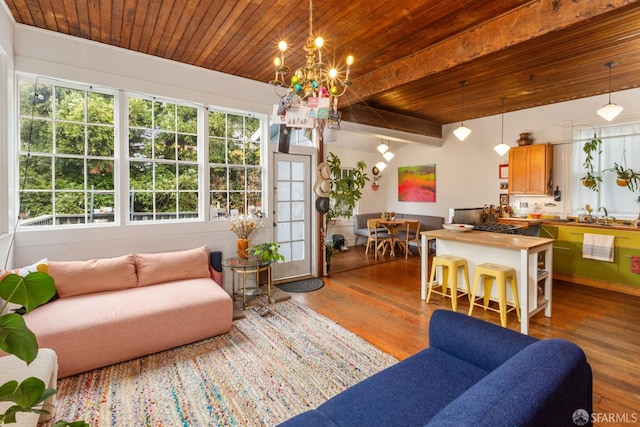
[18,77,116,226]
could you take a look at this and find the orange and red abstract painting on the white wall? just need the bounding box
[398,164,436,202]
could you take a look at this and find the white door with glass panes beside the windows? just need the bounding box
[272,153,312,279]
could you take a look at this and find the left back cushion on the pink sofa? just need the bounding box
[49,254,137,298]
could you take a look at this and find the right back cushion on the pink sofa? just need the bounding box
[135,246,211,286]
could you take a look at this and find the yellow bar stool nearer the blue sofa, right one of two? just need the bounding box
[469,263,520,327]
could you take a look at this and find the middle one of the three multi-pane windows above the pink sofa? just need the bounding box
[128,96,200,221]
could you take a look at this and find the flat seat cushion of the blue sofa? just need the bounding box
[282,348,487,426]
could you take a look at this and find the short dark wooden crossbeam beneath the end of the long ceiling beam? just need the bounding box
[340,104,442,138]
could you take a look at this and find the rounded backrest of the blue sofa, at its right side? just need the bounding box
[428,339,593,427]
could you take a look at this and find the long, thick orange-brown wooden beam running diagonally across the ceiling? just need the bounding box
[340,0,639,109]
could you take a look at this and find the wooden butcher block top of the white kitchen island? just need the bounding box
[420,230,554,250]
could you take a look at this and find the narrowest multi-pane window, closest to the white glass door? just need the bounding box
[208,110,262,219]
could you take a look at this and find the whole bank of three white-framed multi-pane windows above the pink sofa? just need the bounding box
[15,73,268,230]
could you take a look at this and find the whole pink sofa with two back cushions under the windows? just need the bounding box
[24,246,233,378]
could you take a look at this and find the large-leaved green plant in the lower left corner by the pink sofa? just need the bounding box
[0,271,89,427]
